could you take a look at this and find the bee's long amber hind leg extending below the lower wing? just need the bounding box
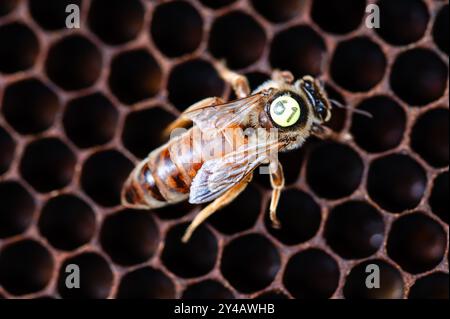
[182,174,253,243]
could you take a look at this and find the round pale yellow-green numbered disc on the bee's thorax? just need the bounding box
[270,96,300,127]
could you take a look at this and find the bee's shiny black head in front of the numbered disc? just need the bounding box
[296,76,331,123]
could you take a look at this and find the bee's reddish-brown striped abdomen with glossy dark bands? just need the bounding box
[122,127,230,209]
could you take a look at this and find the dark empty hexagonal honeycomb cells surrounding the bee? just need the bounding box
[0,0,449,298]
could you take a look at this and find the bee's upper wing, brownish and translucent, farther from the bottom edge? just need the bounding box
[183,93,265,131]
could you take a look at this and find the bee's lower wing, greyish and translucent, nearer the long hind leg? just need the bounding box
[189,139,280,204]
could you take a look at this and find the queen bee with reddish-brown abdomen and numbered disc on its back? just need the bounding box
[122,63,332,242]
